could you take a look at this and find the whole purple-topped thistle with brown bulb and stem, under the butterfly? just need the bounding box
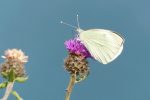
[64,39,91,100]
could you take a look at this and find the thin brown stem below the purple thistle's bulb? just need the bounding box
[65,74,76,100]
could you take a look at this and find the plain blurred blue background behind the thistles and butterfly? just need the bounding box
[0,0,150,100]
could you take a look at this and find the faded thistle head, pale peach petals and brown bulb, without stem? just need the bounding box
[0,49,28,77]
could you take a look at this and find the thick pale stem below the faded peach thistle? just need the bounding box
[1,82,14,100]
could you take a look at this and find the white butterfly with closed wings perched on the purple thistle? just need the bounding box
[61,15,124,64]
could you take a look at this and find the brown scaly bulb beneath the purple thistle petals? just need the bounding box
[65,53,89,82]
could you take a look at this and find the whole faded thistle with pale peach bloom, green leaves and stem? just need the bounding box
[0,49,28,100]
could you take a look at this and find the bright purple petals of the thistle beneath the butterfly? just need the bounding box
[65,39,91,58]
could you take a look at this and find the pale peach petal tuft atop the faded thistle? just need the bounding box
[2,49,28,63]
